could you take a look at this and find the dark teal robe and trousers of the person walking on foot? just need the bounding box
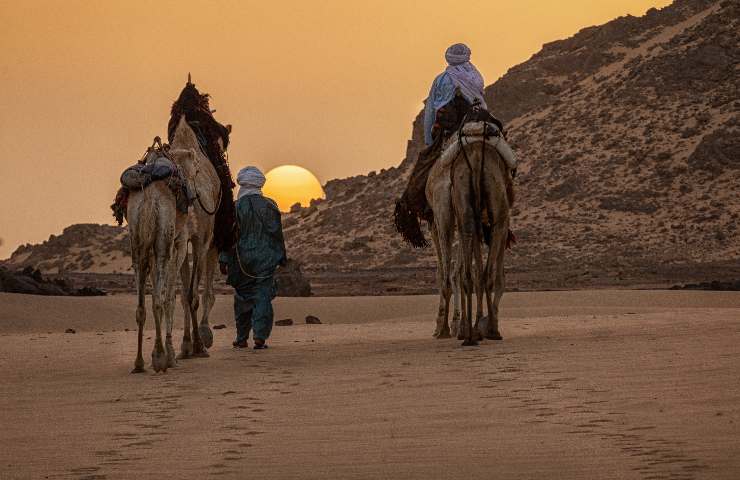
[219,194,286,341]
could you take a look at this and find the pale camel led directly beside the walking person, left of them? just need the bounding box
[170,115,223,358]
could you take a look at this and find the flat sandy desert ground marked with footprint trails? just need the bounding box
[0,291,740,479]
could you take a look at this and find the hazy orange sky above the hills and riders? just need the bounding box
[0,0,670,258]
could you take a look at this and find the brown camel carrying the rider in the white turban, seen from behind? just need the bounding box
[426,122,512,345]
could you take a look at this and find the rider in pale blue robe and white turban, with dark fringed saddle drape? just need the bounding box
[394,43,516,248]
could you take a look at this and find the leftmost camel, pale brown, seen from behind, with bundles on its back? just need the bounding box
[126,144,195,373]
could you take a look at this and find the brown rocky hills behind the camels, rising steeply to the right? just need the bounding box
[5,0,740,293]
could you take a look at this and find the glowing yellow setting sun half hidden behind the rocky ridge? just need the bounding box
[263,165,324,212]
